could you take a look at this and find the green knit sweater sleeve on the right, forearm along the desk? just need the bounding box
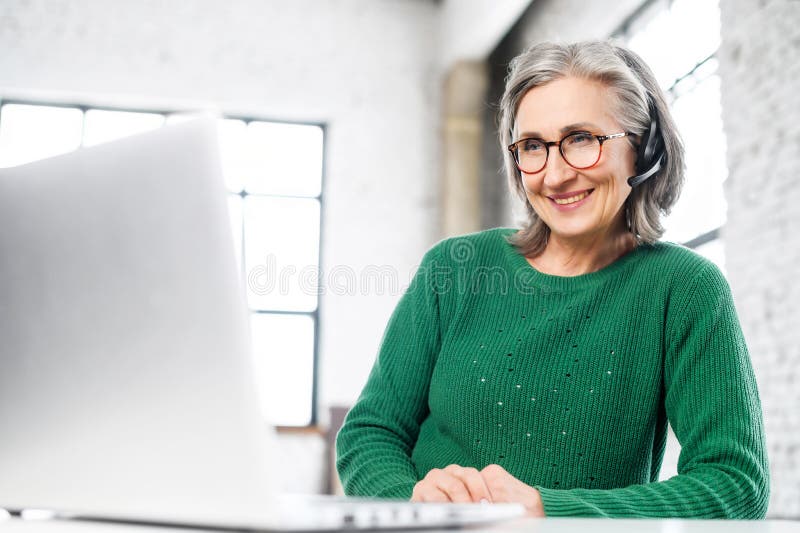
[537,263,769,519]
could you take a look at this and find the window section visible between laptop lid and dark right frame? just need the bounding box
[228,119,323,426]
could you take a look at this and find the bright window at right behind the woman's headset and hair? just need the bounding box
[615,0,728,271]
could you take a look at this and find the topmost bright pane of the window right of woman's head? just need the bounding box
[628,0,720,89]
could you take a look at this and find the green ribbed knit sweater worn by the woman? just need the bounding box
[337,228,769,518]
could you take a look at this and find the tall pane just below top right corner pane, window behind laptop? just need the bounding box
[244,196,320,311]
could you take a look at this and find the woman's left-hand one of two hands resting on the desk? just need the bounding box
[411,465,492,503]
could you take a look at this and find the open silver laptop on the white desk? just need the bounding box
[0,119,524,531]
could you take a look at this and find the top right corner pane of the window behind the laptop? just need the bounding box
[244,122,322,196]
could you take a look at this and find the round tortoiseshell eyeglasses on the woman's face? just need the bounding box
[508,131,633,174]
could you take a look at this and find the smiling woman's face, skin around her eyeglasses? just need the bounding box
[514,77,636,244]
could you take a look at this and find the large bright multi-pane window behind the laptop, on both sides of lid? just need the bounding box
[0,98,324,426]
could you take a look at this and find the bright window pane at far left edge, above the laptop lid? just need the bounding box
[0,104,83,167]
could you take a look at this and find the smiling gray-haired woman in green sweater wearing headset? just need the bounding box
[337,42,768,518]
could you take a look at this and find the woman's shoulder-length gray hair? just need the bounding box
[499,41,684,256]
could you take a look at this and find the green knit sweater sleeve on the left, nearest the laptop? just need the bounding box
[336,247,443,499]
